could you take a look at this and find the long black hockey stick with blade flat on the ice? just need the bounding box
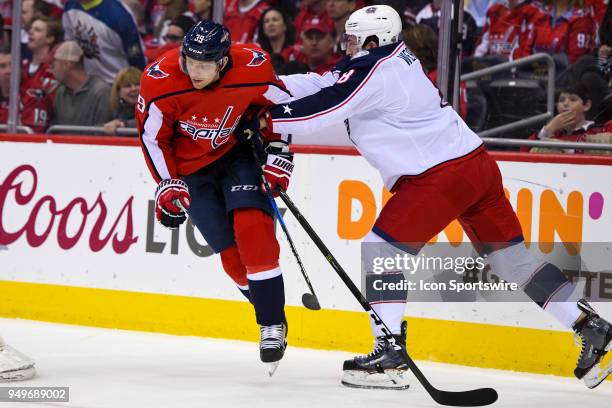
[279,191,497,407]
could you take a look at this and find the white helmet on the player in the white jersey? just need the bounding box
[344,5,402,48]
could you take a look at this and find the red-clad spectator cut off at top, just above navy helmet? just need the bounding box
[223,0,270,44]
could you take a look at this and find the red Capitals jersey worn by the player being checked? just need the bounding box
[136,44,290,182]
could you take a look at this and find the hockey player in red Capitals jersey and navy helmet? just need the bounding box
[136,21,293,375]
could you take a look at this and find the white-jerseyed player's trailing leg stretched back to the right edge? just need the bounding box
[459,151,612,388]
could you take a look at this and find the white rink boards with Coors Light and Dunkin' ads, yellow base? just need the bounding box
[0,135,612,375]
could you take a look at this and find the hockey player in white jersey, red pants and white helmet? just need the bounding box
[241,6,612,389]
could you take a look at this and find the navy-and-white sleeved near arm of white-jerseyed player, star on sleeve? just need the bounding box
[270,69,386,134]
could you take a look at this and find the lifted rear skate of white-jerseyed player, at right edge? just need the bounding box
[572,299,612,388]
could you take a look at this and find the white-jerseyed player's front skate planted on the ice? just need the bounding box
[342,321,410,390]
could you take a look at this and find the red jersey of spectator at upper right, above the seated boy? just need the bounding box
[513,3,597,64]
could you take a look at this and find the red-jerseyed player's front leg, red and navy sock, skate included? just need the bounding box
[221,148,287,372]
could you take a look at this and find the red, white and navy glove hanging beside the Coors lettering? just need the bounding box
[155,179,191,229]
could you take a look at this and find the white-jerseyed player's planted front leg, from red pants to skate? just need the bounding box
[342,156,474,389]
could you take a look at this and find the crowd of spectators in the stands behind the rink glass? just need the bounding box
[0,0,612,152]
